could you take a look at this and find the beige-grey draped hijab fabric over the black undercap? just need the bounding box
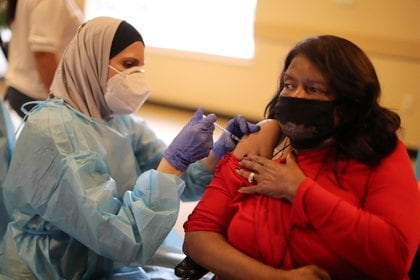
[50,17,121,120]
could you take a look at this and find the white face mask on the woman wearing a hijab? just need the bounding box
[104,65,151,115]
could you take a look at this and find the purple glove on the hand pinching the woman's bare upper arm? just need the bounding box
[213,115,260,159]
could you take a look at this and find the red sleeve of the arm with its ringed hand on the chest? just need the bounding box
[292,142,420,279]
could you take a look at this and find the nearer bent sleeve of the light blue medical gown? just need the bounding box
[5,106,185,265]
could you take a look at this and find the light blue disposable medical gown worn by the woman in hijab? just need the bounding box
[1,100,212,279]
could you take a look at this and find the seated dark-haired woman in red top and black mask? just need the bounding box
[184,35,420,280]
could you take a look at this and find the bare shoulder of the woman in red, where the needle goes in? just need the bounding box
[233,120,282,158]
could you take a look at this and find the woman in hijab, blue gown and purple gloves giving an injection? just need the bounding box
[0,17,258,279]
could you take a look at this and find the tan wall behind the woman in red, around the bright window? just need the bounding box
[78,0,420,147]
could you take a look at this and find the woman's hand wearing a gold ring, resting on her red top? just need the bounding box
[237,153,306,202]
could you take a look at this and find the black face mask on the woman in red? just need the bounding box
[274,96,334,150]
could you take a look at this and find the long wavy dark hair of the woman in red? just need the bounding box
[264,35,401,166]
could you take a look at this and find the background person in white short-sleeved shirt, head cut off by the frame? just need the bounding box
[5,0,83,118]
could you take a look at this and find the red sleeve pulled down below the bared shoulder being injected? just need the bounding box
[184,153,246,234]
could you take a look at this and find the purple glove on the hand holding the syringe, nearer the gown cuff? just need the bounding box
[163,108,216,170]
